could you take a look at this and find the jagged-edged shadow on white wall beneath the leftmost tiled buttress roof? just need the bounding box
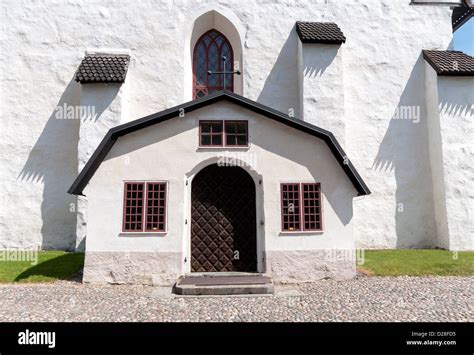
[17,78,81,250]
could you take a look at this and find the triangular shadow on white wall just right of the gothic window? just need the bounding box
[257,26,301,117]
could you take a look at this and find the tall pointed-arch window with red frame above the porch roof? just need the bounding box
[193,30,234,99]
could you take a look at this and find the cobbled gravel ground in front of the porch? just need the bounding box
[0,277,474,322]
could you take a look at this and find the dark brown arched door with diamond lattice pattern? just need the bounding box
[191,165,257,272]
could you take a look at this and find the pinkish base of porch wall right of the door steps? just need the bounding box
[266,250,356,284]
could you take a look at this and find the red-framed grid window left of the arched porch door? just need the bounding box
[123,182,166,232]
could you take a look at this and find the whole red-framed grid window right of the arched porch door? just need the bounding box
[281,183,322,232]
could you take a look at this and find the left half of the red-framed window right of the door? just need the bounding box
[281,184,301,231]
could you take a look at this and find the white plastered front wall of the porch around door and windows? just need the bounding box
[84,102,357,284]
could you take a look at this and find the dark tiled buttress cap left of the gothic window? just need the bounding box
[76,54,130,84]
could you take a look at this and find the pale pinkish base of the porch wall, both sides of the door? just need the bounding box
[83,250,356,286]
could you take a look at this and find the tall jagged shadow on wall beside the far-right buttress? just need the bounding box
[372,55,436,248]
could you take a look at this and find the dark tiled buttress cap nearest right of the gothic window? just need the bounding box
[296,21,346,44]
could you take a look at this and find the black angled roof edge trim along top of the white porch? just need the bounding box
[68,91,370,195]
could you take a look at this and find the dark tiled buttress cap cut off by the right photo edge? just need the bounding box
[423,50,474,76]
